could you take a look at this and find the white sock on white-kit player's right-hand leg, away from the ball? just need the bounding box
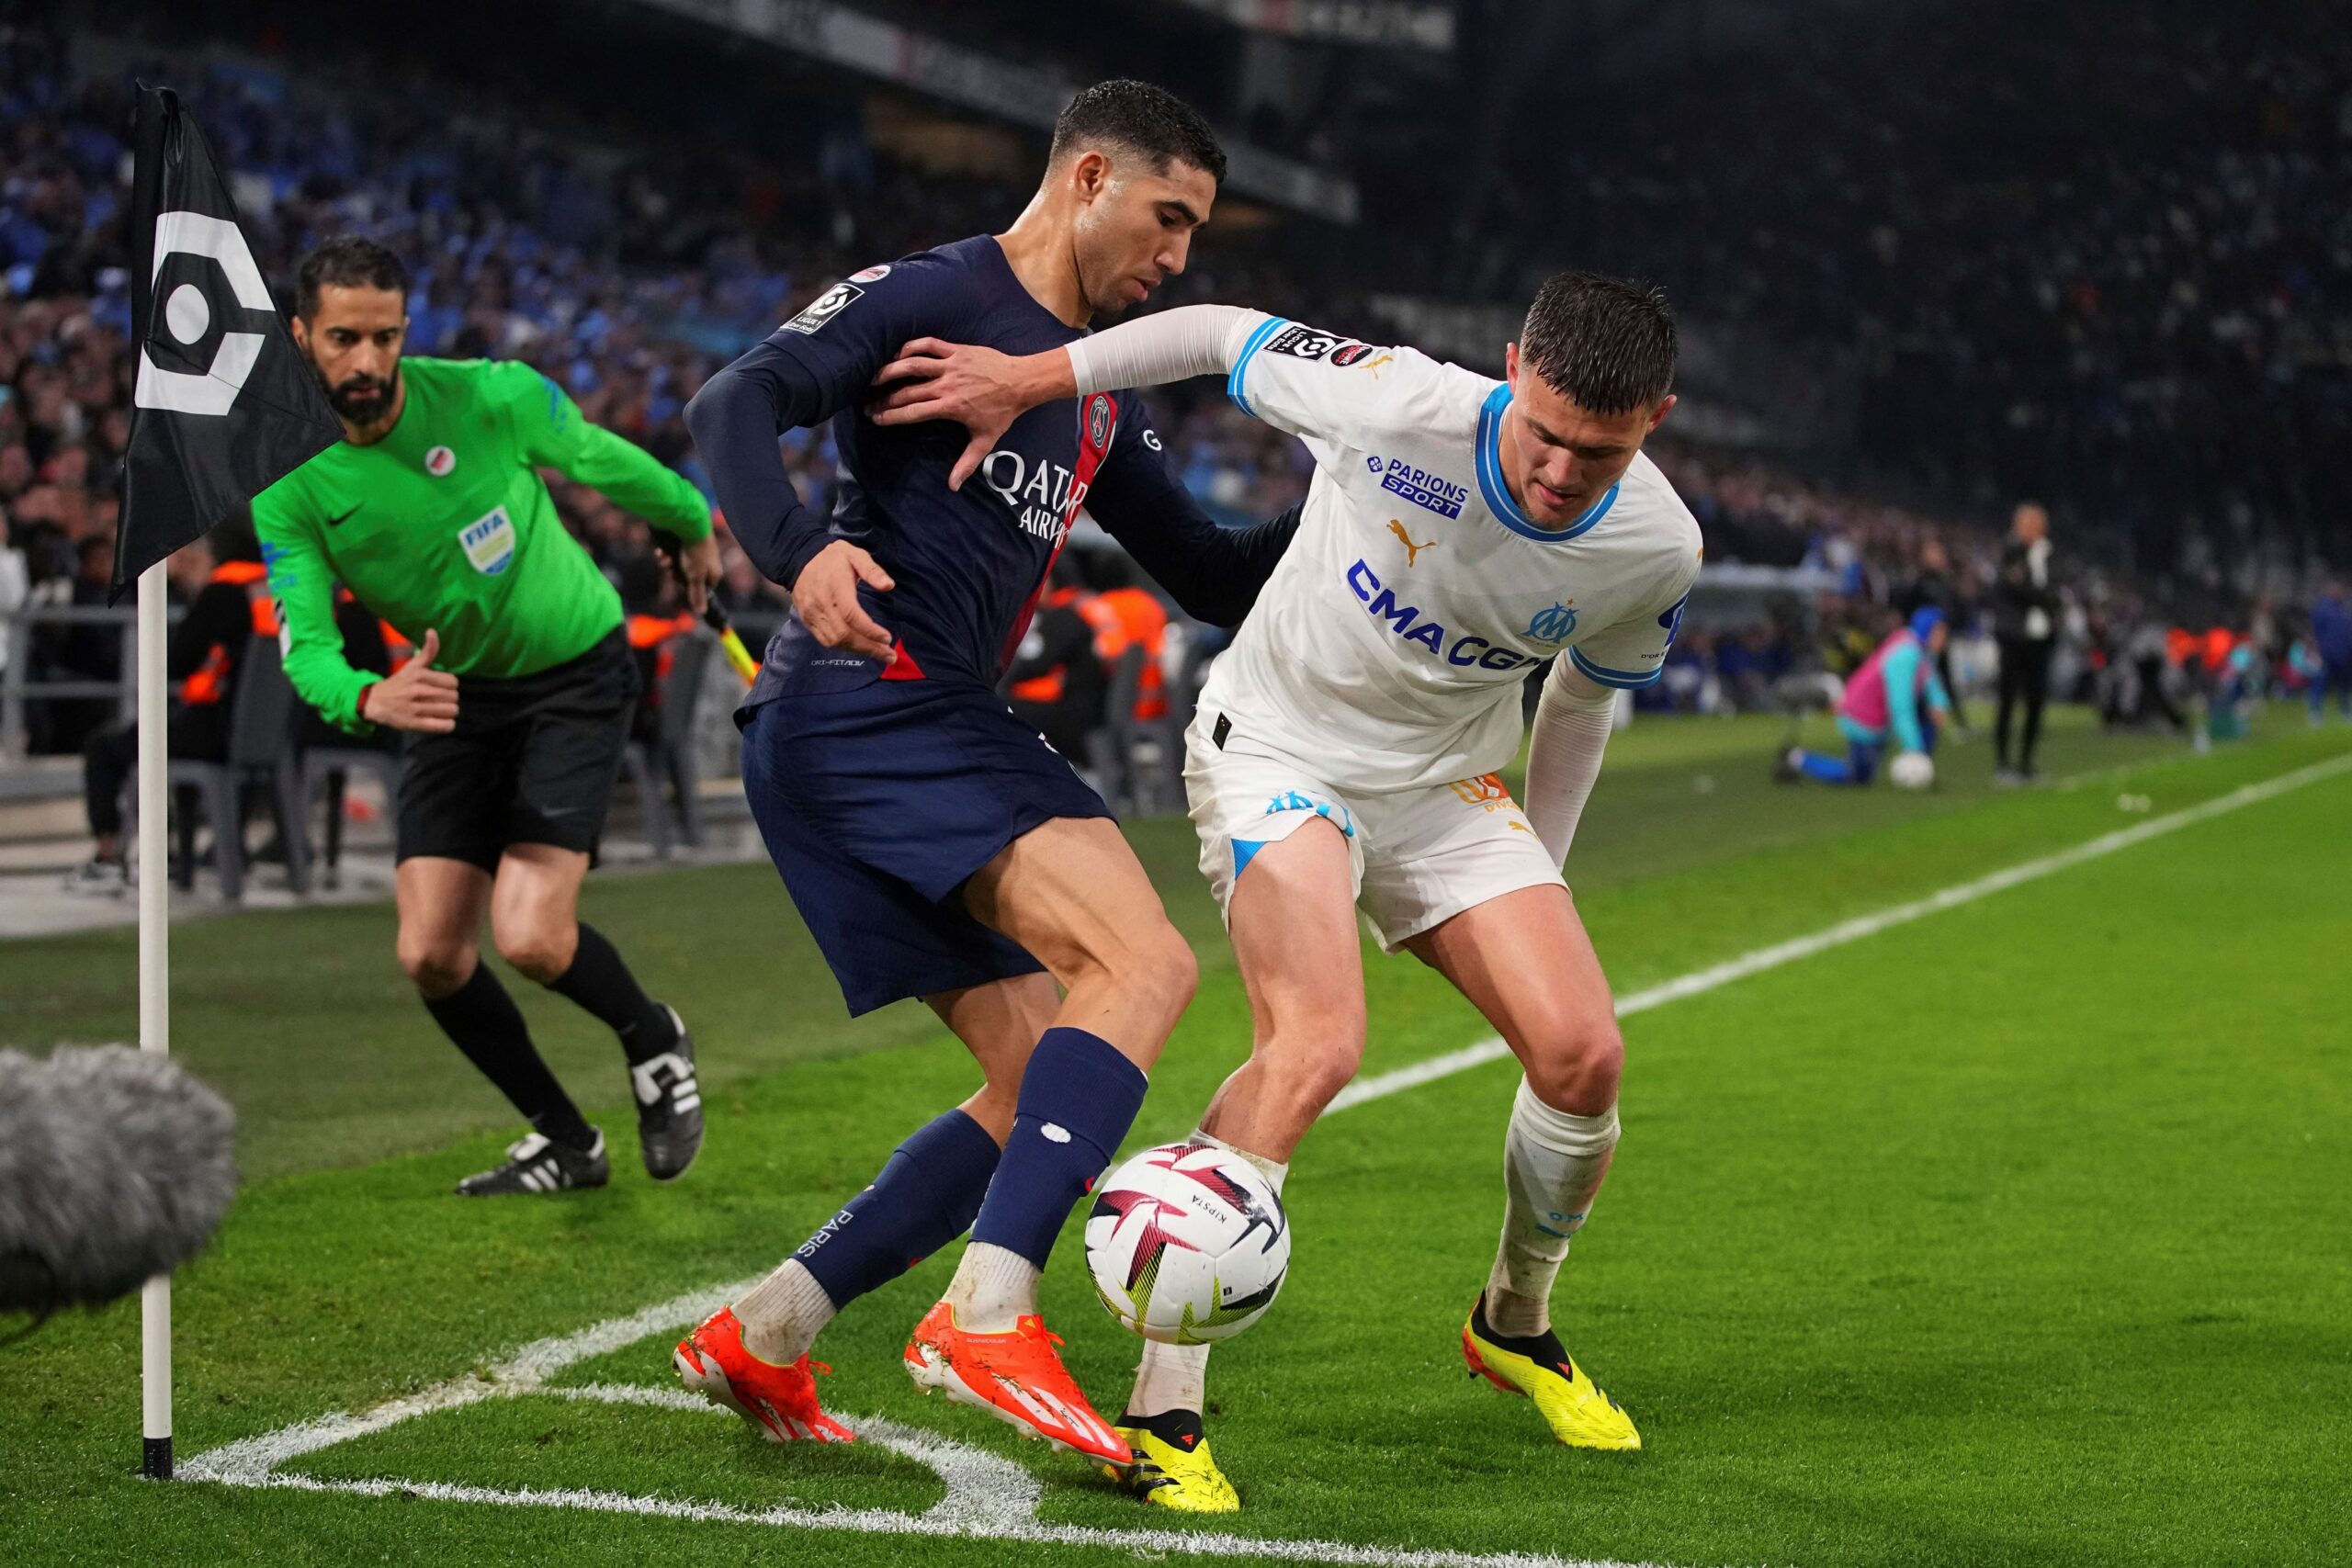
[1487,1079,1618,1340]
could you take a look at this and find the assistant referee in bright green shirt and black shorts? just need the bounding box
[254,235,719,1197]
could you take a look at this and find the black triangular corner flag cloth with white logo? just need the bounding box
[110,83,344,600]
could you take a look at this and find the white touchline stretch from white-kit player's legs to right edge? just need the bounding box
[1324,752,2352,1117]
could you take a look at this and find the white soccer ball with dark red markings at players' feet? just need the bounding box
[1087,1143,1291,1345]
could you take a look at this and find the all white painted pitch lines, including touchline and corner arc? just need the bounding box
[181,755,2352,1568]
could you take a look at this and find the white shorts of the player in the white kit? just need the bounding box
[1183,710,1562,952]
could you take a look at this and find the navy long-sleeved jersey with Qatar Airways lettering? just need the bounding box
[692,235,1296,705]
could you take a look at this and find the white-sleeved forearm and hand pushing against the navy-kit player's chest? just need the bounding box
[870,306,1270,489]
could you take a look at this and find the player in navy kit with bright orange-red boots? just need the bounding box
[677,83,1296,1467]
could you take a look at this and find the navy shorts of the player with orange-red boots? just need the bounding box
[736,682,1110,1016]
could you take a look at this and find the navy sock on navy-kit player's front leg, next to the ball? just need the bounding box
[971,1030,1148,1269]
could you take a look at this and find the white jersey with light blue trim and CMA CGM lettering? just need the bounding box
[1202,317,1701,795]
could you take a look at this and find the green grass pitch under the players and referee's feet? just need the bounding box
[0,712,2352,1568]
